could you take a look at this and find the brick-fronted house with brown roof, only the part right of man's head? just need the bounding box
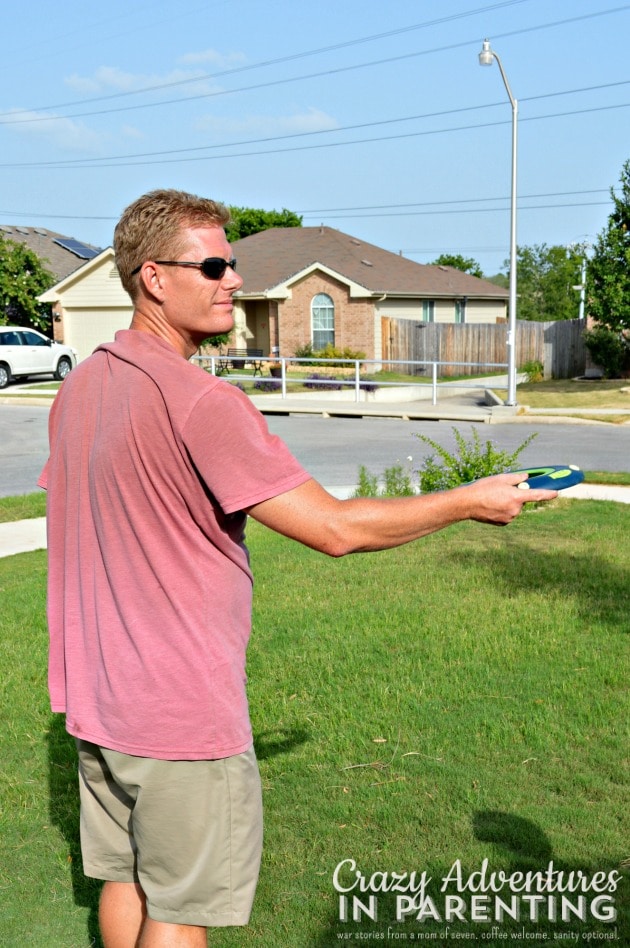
[232,227,509,359]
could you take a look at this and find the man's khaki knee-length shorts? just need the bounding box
[77,739,262,927]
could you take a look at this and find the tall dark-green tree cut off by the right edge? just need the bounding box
[586,160,630,332]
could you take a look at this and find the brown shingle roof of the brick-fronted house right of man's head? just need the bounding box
[232,227,508,299]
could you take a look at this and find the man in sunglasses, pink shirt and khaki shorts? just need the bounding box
[40,190,556,948]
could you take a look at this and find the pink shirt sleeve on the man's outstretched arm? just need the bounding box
[183,385,311,514]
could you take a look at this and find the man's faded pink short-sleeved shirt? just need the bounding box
[39,330,309,760]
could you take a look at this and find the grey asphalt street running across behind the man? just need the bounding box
[0,405,630,497]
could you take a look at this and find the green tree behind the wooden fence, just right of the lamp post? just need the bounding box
[503,244,582,322]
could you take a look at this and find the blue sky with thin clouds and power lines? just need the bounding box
[0,0,630,275]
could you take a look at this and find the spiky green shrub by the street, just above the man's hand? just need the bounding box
[415,428,536,494]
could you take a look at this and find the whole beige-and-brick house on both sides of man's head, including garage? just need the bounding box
[39,227,508,359]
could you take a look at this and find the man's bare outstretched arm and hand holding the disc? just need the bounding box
[248,474,557,556]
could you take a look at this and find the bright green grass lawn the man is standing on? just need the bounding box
[0,500,630,948]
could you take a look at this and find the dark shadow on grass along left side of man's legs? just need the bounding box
[46,714,102,948]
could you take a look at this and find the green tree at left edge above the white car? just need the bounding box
[0,237,55,330]
